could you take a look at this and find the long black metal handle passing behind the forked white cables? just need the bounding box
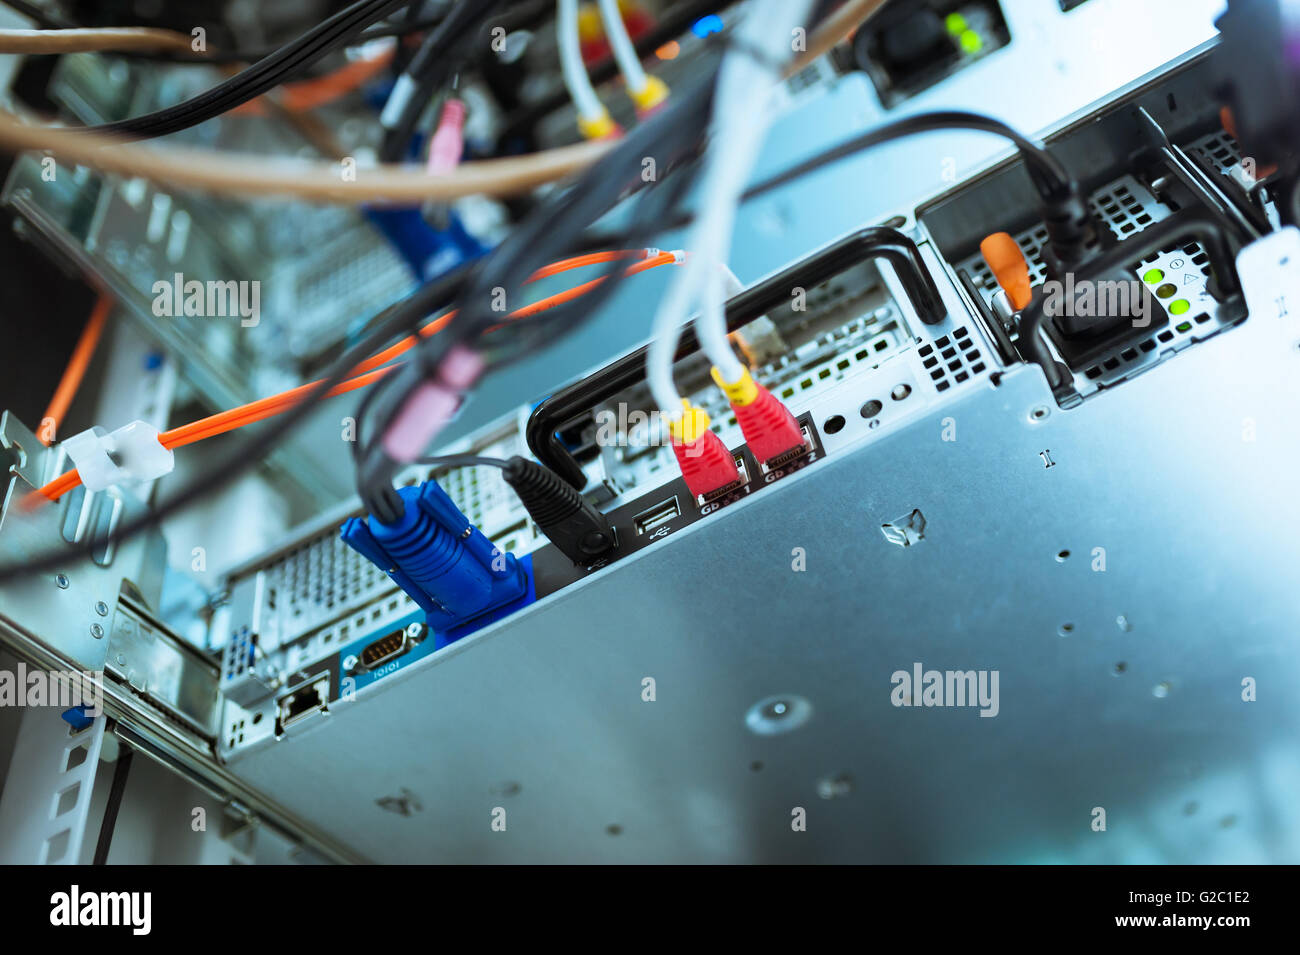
[524,226,948,490]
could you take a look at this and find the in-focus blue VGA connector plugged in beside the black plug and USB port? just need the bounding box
[342,481,536,646]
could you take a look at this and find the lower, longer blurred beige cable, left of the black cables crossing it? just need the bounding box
[0,110,614,203]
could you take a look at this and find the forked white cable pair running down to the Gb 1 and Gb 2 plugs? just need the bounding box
[646,0,813,421]
